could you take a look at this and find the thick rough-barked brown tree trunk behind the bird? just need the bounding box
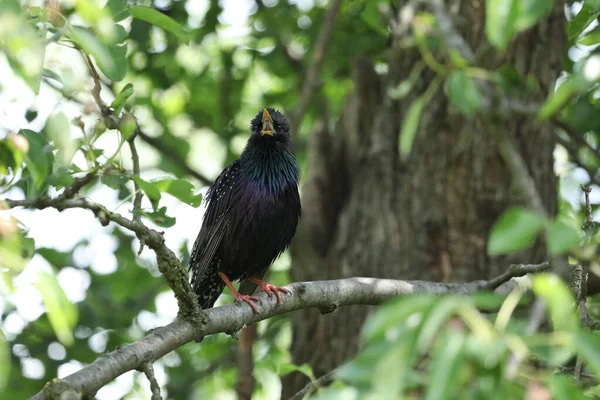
[282,0,565,399]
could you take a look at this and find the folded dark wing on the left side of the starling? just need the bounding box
[189,160,239,288]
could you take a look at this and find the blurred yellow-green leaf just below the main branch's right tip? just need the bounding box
[532,274,579,331]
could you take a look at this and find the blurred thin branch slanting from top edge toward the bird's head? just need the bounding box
[291,0,342,139]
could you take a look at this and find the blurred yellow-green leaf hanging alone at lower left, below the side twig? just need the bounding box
[36,272,77,346]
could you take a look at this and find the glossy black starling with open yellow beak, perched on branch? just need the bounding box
[189,108,301,313]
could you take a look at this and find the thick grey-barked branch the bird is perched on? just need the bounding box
[31,263,549,400]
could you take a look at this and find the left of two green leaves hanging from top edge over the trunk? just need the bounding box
[485,0,520,51]
